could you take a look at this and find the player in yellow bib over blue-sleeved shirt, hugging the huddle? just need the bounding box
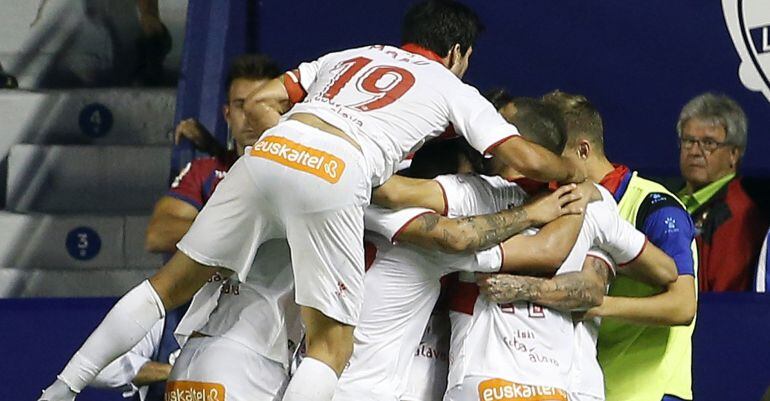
[544,92,697,401]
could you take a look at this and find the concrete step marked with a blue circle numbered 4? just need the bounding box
[0,88,176,154]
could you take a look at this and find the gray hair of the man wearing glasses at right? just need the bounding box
[676,92,748,155]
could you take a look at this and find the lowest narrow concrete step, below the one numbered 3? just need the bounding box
[0,268,155,298]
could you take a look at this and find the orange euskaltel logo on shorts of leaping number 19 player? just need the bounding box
[249,136,345,184]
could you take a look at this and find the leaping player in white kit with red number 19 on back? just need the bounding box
[43,1,585,401]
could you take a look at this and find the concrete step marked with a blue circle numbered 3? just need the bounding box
[0,211,163,268]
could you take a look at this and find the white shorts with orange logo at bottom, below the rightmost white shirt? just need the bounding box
[444,376,572,401]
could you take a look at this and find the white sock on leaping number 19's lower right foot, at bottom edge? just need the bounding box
[283,357,338,401]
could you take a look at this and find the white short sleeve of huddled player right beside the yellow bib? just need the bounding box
[587,202,647,266]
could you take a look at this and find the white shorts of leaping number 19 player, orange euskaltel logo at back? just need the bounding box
[177,121,371,325]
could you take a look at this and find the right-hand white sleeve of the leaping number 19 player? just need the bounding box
[440,83,519,154]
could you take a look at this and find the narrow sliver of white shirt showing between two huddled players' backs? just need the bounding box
[401,311,450,401]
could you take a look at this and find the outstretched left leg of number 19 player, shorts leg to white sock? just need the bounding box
[41,160,270,401]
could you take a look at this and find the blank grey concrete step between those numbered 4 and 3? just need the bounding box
[6,145,171,214]
